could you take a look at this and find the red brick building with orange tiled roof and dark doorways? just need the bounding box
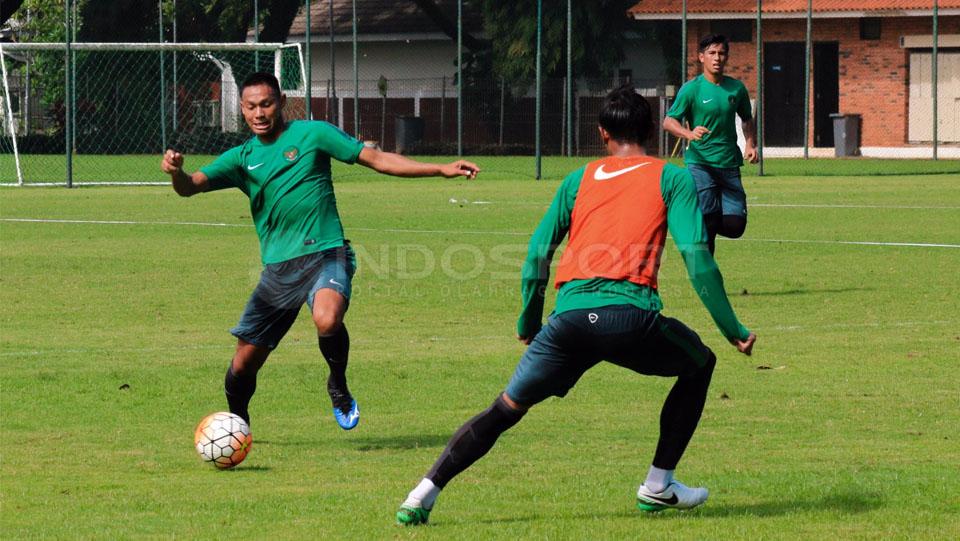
[630,0,960,156]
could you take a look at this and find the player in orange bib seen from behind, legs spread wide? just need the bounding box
[397,85,756,525]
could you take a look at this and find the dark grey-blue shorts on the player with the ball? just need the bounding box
[230,244,356,349]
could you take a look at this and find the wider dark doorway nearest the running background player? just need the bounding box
[763,42,804,147]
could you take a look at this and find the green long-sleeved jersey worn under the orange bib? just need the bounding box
[517,160,750,340]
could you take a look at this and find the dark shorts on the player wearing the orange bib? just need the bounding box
[506,305,713,406]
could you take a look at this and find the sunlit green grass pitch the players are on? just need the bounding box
[0,158,960,540]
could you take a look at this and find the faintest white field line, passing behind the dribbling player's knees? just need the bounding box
[0,320,960,359]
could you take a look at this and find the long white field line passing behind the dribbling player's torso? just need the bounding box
[0,218,960,248]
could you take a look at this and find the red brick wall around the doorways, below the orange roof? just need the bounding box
[687,16,960,147]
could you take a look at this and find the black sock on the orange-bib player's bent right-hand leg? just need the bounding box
[653,353,717,470]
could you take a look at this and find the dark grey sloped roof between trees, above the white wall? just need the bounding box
[290,0,483,38]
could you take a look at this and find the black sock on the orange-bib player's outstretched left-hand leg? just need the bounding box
[426,395,526,488]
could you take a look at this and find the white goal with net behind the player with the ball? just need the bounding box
[0,43,306,185]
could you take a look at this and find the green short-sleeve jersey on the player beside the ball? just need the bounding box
[200,120,363,265]
